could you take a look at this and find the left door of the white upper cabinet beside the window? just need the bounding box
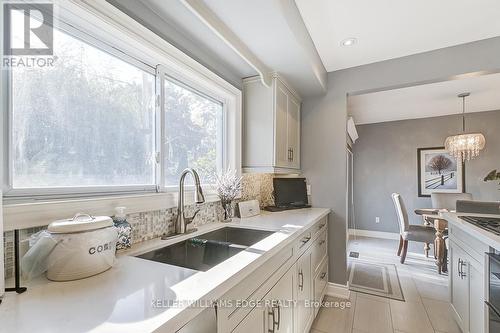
[274,80,290,168]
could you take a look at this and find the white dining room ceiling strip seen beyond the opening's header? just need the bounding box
[348,74,500,125]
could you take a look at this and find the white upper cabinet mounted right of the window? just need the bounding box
[243,74,300,173]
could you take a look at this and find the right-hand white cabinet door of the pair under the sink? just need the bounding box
[266,268,294,333]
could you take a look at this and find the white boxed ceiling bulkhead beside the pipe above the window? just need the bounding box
[200,0,326,97]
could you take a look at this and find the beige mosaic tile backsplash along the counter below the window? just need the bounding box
[3,174,274,279]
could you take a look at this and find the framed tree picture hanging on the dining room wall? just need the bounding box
[417,147,465,197]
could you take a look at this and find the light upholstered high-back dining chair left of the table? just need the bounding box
[391,193,436,264]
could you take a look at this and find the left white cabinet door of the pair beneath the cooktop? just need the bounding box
[449,241,469,332]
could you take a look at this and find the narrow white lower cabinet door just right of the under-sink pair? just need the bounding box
[295,249,313,333]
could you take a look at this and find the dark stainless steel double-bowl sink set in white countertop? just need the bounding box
[138,227,273,271]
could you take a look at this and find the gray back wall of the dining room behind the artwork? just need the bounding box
[349,111,500,232]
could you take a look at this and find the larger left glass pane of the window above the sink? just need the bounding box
[11,26,155,189]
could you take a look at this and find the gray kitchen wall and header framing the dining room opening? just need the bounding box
[301,37,500,285]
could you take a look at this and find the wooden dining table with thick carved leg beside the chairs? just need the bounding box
[415,208,448,274]
